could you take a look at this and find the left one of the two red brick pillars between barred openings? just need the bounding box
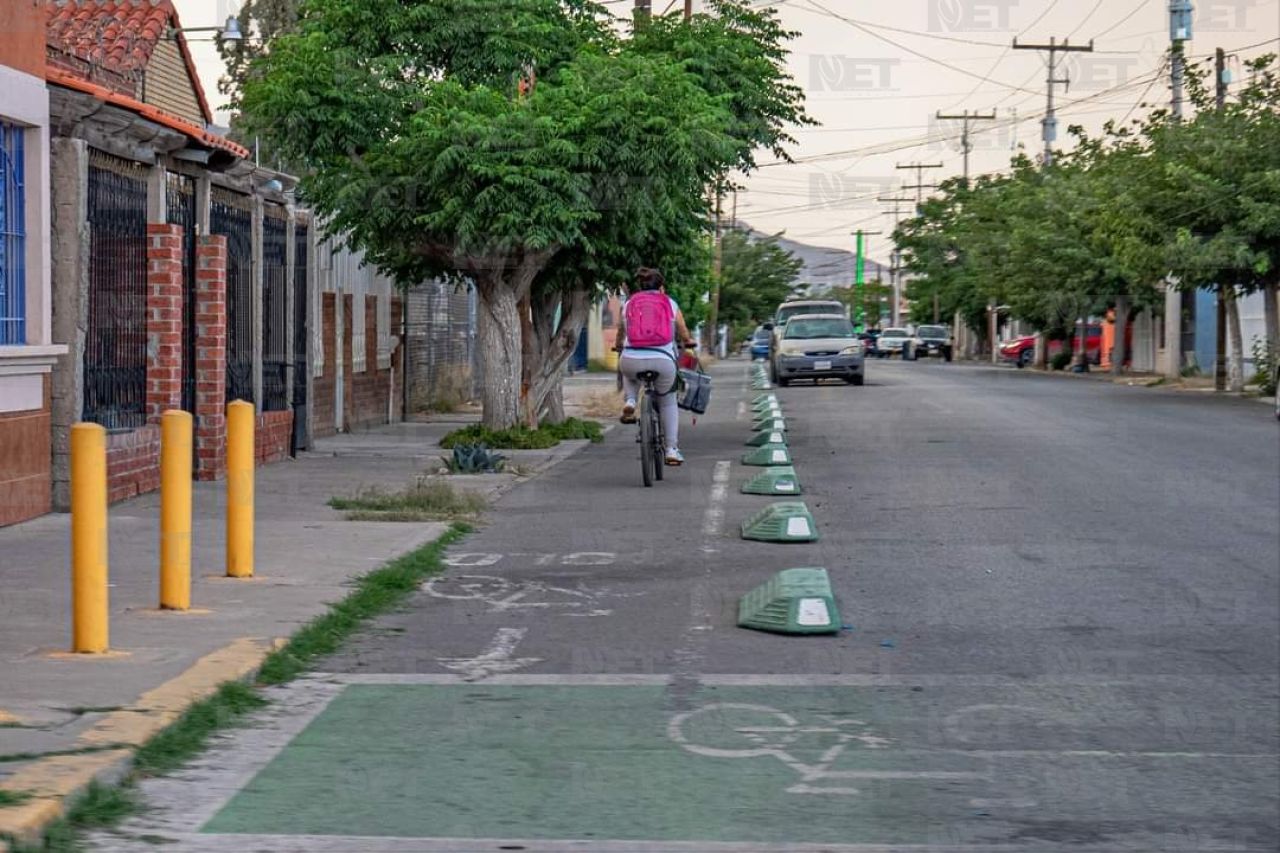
[147,223,182,424]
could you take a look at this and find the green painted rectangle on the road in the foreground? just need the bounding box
[202,684,986,843]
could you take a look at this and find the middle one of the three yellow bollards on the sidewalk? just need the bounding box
[160,410,192,610]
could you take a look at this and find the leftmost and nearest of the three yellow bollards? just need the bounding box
[70,424,108,653]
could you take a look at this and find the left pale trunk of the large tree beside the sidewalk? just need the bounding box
[476,280,522,429]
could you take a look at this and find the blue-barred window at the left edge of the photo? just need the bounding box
[0,122,27,345]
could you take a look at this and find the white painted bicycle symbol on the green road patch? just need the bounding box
[667,702,982,797]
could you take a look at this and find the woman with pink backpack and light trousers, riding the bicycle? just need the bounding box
[613,266,694,465]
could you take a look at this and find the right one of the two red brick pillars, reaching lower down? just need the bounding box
[196,234,227,480]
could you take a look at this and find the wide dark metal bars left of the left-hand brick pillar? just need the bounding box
[82,149,147,429]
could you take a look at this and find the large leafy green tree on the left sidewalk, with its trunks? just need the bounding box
[241,0,799,428]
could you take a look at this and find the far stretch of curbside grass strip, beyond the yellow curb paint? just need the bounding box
[257,524,470,684]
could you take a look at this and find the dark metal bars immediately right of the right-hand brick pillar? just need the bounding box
[209,187,257,403]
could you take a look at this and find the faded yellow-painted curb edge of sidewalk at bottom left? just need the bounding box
[0,637,287,852]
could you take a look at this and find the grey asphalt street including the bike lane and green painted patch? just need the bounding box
[91,360,1280,853]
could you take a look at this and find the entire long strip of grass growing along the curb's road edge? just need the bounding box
[10,524,470,853]
